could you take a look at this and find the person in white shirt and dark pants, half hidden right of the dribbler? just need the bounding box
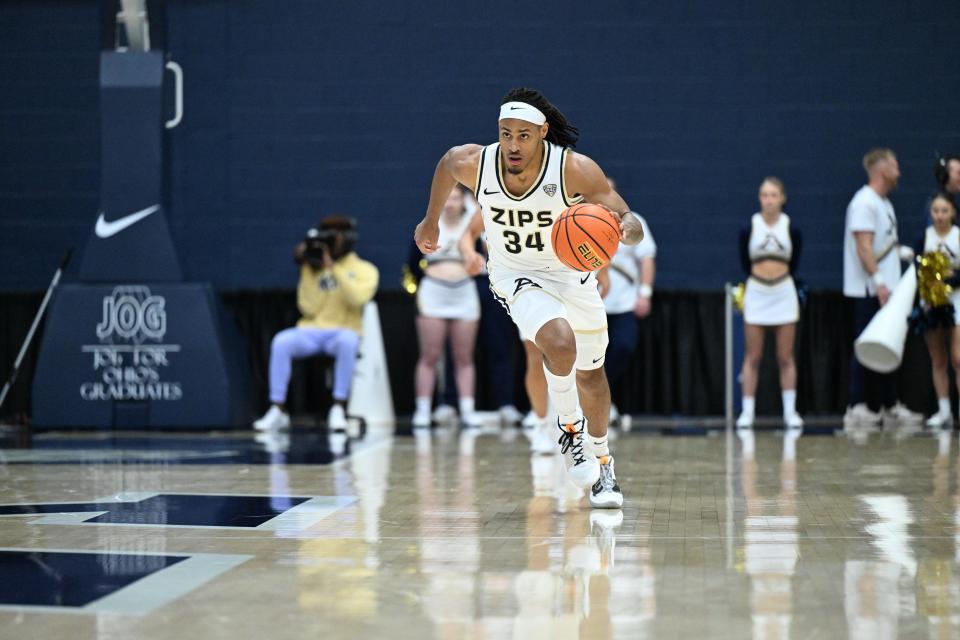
[603,178,657,429]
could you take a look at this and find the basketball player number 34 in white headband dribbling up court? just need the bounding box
[414,88,643,508]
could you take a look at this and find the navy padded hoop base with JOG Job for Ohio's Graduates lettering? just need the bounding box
[33,283,246,427]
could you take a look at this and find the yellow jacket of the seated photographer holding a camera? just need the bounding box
[297,253,380,333]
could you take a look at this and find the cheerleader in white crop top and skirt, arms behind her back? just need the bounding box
[737,177,803,429]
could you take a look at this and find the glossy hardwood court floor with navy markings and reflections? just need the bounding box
[0,422,960,640]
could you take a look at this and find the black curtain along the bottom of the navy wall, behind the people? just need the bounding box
[0,289,936,420]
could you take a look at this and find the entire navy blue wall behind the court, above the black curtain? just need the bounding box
[0,0,960,289]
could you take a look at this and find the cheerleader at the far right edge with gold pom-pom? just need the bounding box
[917,191,960,429]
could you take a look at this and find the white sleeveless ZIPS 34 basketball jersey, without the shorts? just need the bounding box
[475,141,582,272]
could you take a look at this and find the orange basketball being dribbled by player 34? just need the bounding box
[550,203,620,271]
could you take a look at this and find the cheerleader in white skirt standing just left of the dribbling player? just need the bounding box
[412,188,480,428]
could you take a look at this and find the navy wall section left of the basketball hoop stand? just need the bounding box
[0,0,100,289]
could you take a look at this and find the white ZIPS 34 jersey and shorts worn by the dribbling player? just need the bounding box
[474,141,607,369]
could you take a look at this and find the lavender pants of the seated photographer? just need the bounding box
[270,327,360,404]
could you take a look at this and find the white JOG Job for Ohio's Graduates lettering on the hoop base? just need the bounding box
[80,285,183,401]
